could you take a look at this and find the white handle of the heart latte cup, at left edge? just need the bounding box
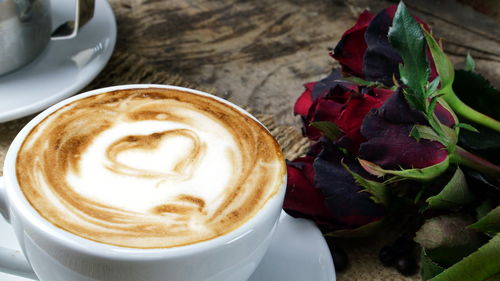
[0,177,37,280]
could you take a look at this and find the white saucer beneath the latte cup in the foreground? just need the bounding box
[0,212,336,281]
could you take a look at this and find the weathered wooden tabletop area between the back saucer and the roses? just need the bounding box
[110,0,353,124]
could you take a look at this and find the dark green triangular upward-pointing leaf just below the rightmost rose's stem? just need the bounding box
[426,167,474,209]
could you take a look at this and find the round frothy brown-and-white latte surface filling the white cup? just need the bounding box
[17,88,285,248]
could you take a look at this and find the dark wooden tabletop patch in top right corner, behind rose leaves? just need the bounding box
[351,0,500,88]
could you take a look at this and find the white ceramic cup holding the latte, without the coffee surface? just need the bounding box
[0,85,286,281]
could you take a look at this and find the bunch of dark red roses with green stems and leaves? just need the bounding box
[284,3,500,281]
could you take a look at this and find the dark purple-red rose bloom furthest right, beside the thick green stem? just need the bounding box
[358,89,456,180]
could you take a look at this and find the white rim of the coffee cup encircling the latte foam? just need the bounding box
[3,84,286,260]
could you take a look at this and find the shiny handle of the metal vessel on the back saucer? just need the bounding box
[51,0,95,40]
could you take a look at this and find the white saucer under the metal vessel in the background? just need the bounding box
[0,0,116,122]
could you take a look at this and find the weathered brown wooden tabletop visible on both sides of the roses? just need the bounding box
[110,0,500,127]
